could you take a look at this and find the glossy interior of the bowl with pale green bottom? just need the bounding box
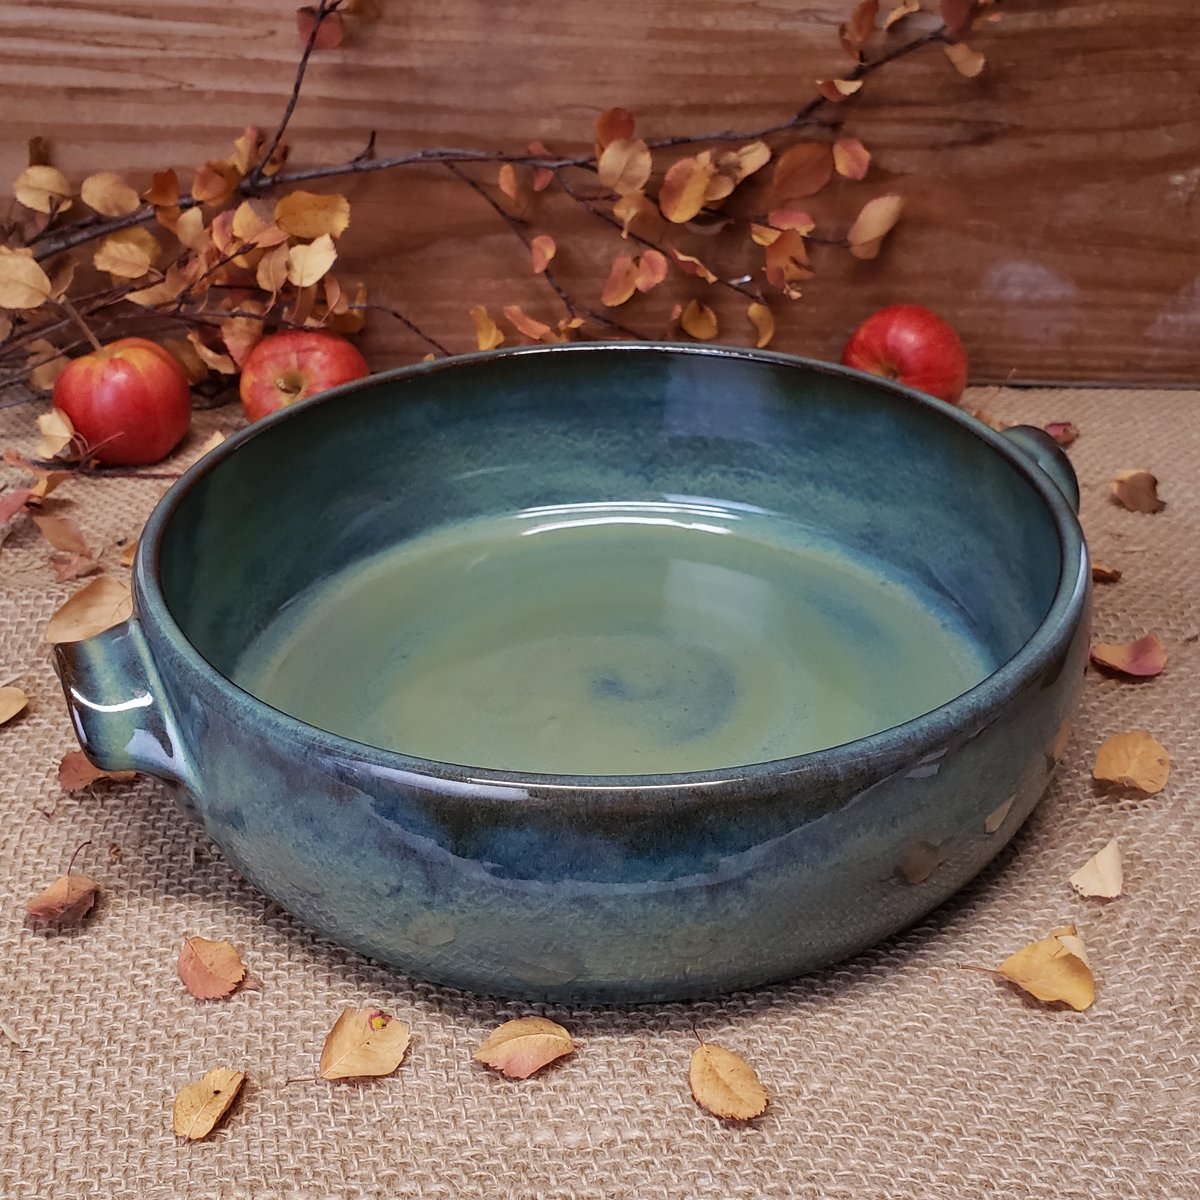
[160,347,1062,775]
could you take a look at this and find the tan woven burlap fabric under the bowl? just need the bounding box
[0,390,1200,1200]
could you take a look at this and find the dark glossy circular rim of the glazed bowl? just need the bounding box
[133,342,1090,803]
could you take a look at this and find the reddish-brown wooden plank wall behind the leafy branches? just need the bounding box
[0,0,1200,383]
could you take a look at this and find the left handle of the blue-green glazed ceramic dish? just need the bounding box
[54,617,196,792]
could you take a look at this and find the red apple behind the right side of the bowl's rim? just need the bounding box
[841,304,967,404]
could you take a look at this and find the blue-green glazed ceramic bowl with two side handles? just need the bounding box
[56,344,1090,1002]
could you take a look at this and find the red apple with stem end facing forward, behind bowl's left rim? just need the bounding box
[239,329,371,421]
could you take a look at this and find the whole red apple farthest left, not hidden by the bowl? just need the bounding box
[54,337,192,467]
